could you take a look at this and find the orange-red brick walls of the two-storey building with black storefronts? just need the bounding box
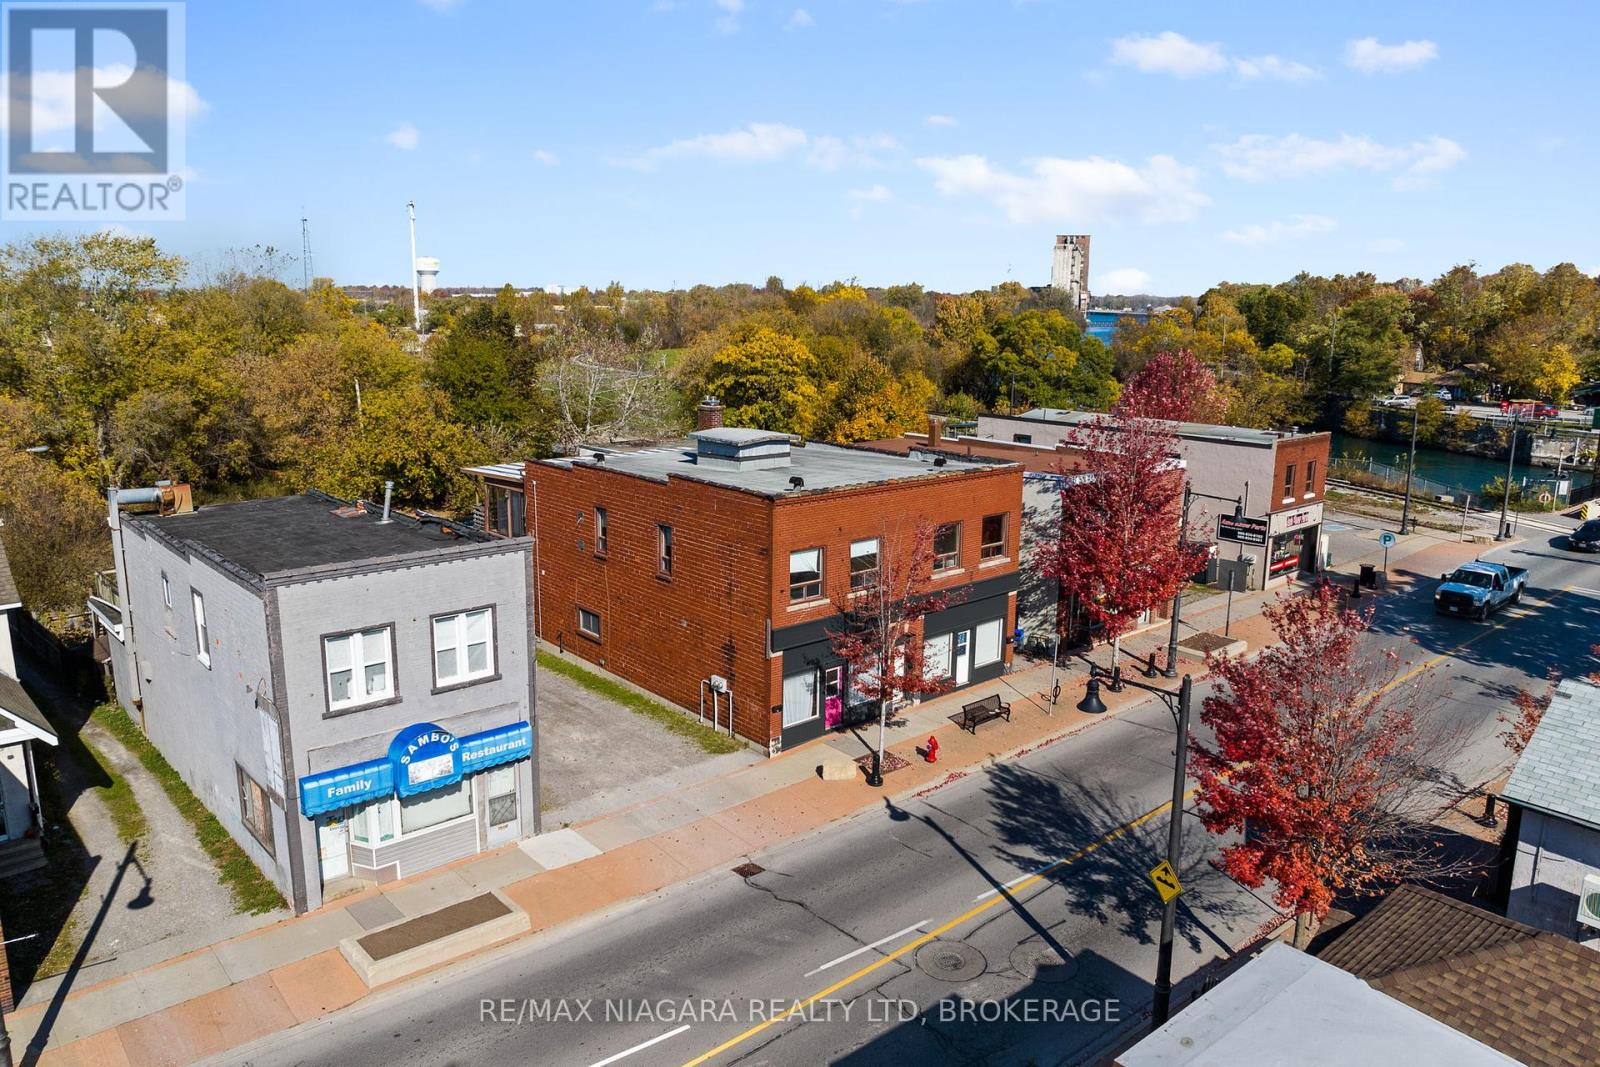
[528,464,1022,744]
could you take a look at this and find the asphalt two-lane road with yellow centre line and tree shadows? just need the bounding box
[221,534,1600,1067]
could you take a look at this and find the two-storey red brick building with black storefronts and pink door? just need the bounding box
[474,412,1022,752]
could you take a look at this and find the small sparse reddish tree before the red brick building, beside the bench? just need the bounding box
[818,520,955,785]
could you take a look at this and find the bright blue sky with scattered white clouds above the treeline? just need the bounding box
[0,0,1600,293]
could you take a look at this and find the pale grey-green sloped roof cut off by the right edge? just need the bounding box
[1501,678,1600,830]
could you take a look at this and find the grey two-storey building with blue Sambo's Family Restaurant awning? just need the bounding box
[91,493,539,912]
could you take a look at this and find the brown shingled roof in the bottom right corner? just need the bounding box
[1320,886,1600,1067]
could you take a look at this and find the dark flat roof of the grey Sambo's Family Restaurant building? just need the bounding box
[132,491,486,577]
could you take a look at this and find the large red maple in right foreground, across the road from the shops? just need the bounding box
[1190,585,1462,947]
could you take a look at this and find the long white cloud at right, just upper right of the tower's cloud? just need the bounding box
[1216,133,1467,189]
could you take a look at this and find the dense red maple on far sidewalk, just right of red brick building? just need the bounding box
[1035,414,1206,661]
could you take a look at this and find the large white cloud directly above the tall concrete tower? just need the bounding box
[917,155,1211,226]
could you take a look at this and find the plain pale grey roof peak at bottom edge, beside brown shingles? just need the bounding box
[1117,942,1517,1067]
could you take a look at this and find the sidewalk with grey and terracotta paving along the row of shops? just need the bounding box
[18,518,1478,1065]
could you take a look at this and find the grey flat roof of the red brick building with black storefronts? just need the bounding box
[538,442,1016,498]
